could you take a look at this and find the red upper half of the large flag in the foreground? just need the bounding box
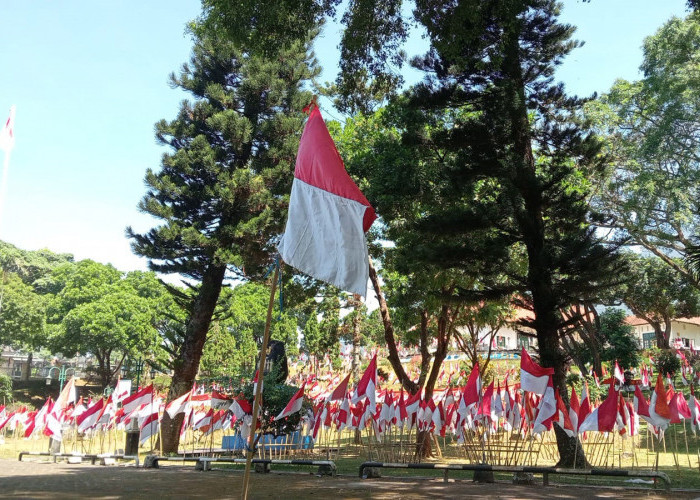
[294,106,377,232]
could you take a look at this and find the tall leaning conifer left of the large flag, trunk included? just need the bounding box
[128,25,317,452]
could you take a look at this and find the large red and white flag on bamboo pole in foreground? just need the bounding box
[278,106,377,297]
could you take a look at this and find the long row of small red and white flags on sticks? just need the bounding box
[0,349,700,443]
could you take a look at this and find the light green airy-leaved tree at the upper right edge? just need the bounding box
[586,12,700,287]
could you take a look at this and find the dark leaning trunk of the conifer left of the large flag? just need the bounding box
[161,265,226,453]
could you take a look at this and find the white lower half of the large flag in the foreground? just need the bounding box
[278,179,369,297]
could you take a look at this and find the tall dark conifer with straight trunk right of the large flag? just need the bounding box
[338,0,619,466]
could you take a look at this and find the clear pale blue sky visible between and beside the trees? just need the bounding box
[0,0,686,271]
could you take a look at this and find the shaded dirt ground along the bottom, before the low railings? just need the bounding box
[0,460,700,500]
